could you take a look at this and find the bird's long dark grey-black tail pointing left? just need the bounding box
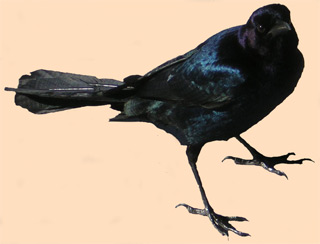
[5,70,132,114]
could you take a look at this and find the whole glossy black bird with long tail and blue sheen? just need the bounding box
[6,4,310,236]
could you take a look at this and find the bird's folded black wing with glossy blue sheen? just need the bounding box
[138,49,246,108]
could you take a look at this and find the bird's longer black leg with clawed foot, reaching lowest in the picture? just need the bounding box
[176,145,249,236]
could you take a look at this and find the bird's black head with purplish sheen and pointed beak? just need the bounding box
[239,4,298,56]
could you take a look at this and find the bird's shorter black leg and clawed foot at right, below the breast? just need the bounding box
[223,136,313,178]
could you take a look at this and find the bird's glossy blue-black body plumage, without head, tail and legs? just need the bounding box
[118,17,303,145]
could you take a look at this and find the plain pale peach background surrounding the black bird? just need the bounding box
[0,0,320,244]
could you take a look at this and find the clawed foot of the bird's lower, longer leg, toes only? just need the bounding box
[176,203,250,236]
